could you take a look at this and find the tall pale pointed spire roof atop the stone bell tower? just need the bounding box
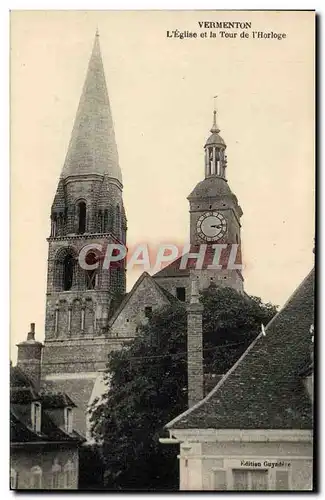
[61,32,122,182]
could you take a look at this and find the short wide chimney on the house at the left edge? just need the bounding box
[17,323,43,391]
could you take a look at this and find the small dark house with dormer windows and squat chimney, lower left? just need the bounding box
[10,323,85,490]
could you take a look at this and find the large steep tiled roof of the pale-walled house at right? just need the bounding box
[166,270,314,430]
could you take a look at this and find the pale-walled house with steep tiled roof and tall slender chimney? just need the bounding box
[160,270,314,491]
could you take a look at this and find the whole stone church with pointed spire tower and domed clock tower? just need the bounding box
[13,33,243,438]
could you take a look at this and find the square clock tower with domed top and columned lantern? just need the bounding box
[188,111,243,289]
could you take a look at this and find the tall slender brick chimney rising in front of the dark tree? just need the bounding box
[187,279,204,408]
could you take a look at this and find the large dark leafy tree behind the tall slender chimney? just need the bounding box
[91,286,276,490]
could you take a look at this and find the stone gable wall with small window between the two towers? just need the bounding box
[110,273,171,337]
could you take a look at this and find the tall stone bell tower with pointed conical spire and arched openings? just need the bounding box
[42,33,127,432]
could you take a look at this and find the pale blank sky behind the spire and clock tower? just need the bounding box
[10,11,315,360]
